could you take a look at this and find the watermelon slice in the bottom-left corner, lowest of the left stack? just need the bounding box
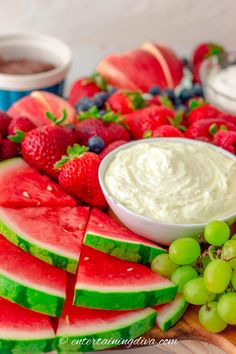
[0,298,56,354]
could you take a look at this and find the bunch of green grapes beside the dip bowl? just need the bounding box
[151,221,236,333]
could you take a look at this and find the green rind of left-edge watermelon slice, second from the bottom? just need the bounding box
[0,274,65,318]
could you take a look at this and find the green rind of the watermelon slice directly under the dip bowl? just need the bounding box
[84,232,167,265]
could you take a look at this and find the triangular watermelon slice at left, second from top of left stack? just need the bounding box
[0,207,89,273]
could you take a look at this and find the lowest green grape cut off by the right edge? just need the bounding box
[217,293,236,325]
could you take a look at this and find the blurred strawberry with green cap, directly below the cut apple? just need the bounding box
[106,90,145,114]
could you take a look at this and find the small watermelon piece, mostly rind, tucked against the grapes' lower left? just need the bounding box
[153,294,188,332]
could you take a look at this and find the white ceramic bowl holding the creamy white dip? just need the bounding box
[99,138,236,245]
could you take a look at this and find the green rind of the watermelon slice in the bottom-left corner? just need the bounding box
[0,336,57,354]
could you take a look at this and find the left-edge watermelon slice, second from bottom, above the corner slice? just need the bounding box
[0,235,66,317]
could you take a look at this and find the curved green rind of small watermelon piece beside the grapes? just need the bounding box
[156,296,188,332]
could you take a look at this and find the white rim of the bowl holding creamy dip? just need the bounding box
[98,137,236,229]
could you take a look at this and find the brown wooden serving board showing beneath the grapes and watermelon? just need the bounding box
[109,210,236,354]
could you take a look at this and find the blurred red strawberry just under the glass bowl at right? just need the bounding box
[188,101,224,124]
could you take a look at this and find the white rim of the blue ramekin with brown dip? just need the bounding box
[0,32,72,91]
